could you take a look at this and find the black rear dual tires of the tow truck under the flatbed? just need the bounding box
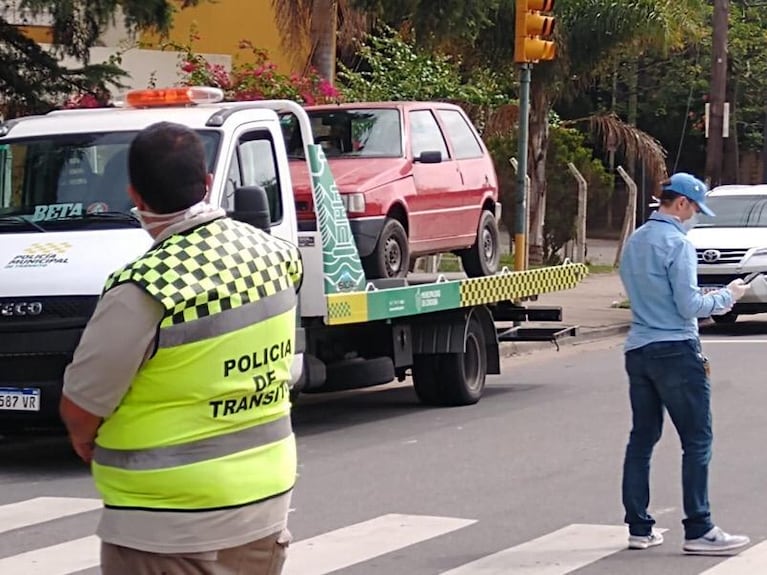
[413,318,487,406]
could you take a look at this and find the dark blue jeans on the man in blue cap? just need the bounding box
[623,340,714,539]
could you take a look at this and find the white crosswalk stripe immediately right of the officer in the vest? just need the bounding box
[284,514,476,575]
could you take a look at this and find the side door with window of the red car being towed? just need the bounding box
[407,109,468,251]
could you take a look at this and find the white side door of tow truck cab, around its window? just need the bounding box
[221,123,298,244]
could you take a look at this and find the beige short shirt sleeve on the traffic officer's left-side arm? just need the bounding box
[63,284,163,417]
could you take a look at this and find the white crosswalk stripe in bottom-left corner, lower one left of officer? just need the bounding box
[0,535,101,575]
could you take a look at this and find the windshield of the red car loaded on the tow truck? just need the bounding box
[281,108,403,159]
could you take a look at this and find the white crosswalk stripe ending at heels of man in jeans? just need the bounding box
[441,524,627,575]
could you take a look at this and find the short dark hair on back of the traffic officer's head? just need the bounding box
[128,122,208,214]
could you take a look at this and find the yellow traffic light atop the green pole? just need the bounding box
[514,0,556,62]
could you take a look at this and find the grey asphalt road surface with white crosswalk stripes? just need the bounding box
[0,317,767,575]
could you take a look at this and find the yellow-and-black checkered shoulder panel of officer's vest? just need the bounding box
[104,218,303,325]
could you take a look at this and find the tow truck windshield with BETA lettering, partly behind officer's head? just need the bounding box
[0,130,220,233]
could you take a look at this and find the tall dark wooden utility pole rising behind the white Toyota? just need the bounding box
[706,0,730,188]
